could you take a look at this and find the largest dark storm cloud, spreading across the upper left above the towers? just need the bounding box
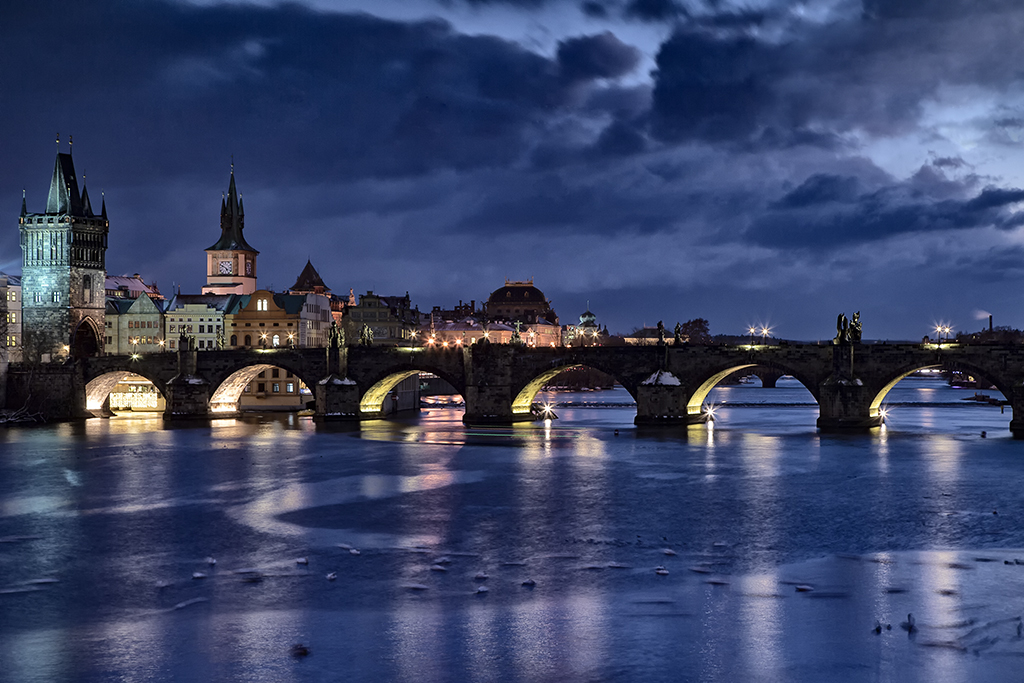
[0,1,638,189]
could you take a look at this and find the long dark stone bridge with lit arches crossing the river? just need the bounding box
[8,342,1024,436]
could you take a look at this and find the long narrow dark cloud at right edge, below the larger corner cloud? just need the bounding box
[749,170,1024,250]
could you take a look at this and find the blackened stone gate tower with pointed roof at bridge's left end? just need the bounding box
[18,146,110,361]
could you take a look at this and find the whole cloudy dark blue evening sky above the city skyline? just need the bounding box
[0,0,1024,340]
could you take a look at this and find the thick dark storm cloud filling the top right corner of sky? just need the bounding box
[652,2,1024,148]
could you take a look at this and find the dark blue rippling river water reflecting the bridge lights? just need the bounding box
[0,378,1024,682]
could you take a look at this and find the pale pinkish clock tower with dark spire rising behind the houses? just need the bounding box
[203,163,259,294]
